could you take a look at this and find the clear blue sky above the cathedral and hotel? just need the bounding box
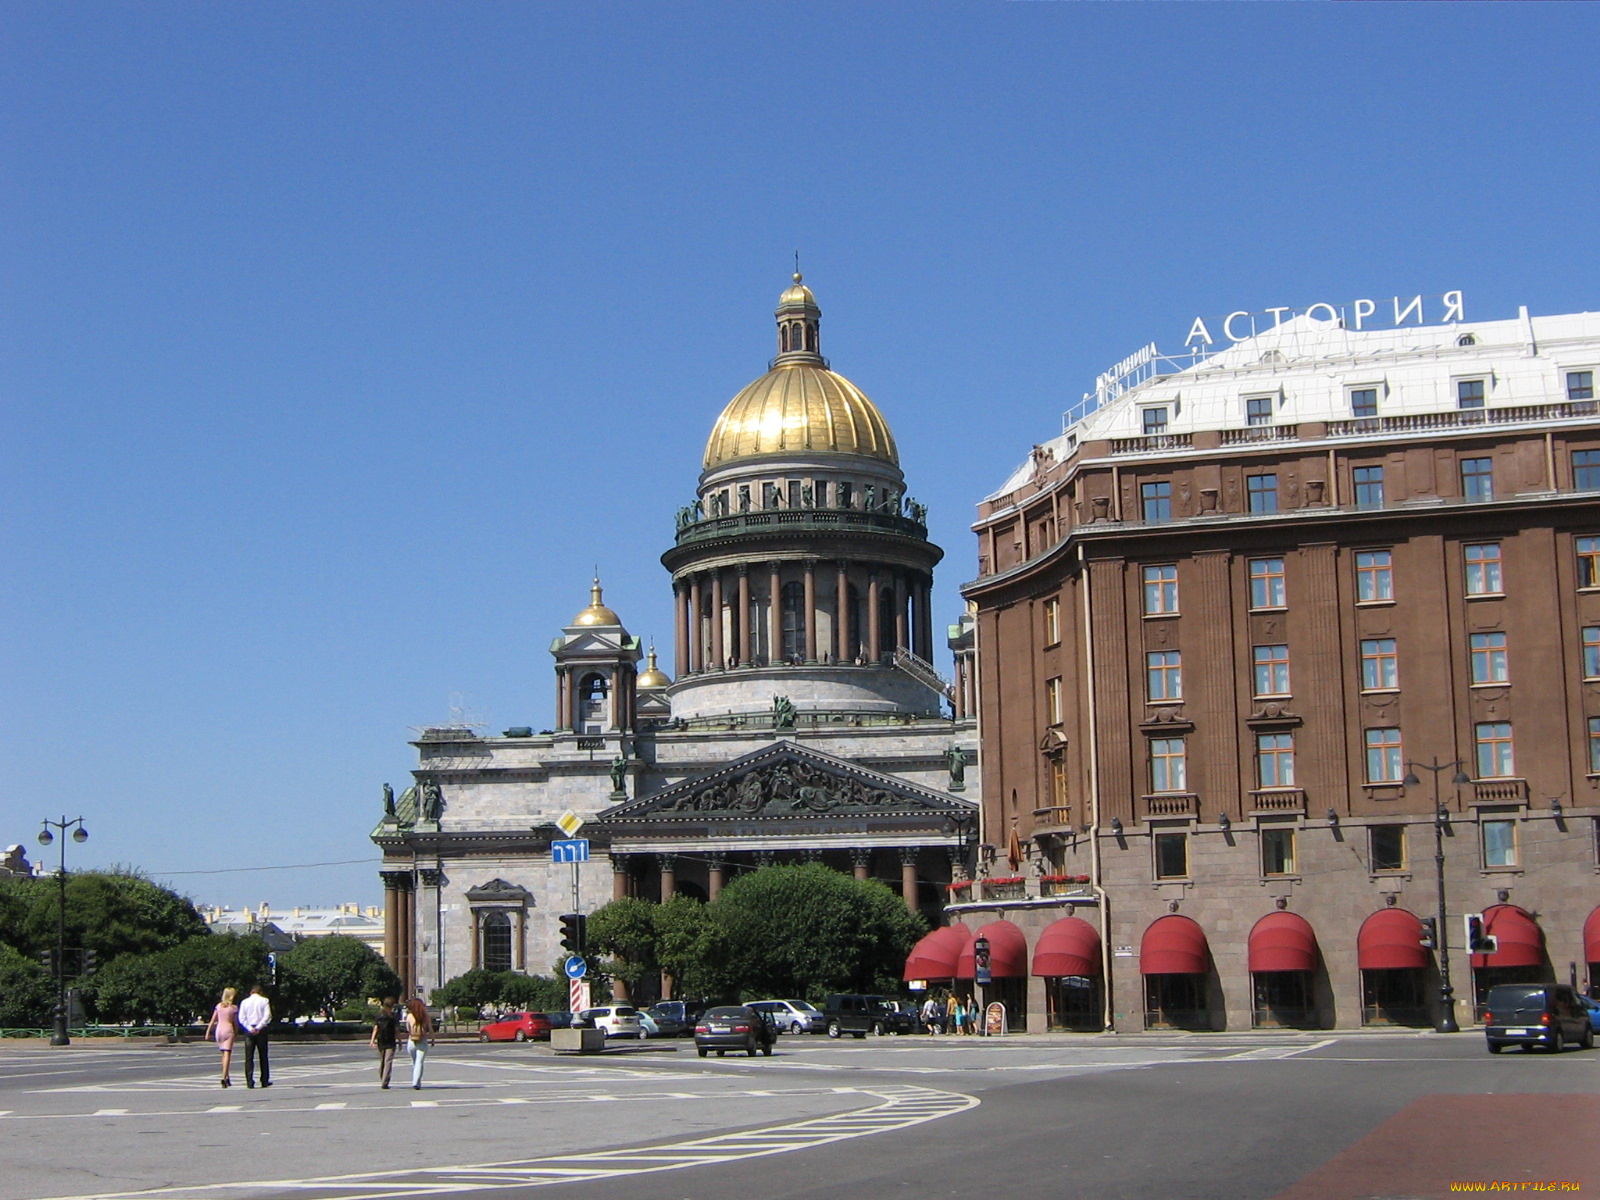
[0,0,1600,906]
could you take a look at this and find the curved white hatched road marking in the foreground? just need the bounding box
[31,1085,979,1200]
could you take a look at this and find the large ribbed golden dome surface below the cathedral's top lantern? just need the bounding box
[702,362,899,470]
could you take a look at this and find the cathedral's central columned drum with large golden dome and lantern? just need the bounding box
[662,272,942,720]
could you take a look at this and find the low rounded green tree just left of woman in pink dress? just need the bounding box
[85,936,267,1026]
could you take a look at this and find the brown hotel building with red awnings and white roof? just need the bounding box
[949,298,1600,1030]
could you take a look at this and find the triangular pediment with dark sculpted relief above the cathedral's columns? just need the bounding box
[600,741,976,827]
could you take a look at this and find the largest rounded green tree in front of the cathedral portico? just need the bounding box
[707,862,928,1000]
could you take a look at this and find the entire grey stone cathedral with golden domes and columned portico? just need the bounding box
[373,275,979,1000]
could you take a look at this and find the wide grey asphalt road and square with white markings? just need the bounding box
[0,1032,1600,1200]
